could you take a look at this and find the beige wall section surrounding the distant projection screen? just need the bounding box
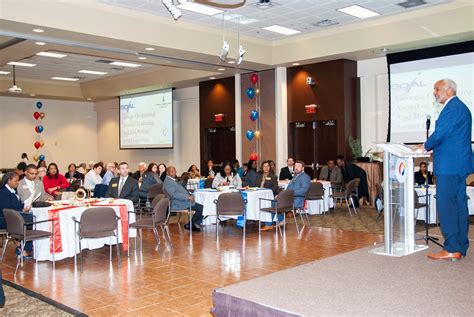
[95,86,200,174]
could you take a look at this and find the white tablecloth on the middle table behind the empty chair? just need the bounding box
[194,189,273,224]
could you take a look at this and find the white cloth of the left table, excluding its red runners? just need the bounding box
[32,199,136,261]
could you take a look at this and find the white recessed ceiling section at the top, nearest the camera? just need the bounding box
[96,0,452,40]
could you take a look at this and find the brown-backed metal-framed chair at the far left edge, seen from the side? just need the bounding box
[2,208,56,275]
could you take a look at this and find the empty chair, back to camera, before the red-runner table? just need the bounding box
[72,207,120,272]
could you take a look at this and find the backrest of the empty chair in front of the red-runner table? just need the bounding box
[79,207,117,234]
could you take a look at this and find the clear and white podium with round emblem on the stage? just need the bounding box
[369,143,429,257]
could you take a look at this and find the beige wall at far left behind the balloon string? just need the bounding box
[0,97,97,173]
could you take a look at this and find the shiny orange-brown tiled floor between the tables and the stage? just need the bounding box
[3,211,382,316]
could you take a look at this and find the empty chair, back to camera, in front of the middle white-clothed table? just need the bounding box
[214,193,247,240]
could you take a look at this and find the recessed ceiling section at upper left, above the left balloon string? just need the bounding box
[0,50,154,83]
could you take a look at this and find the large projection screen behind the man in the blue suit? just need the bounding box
[387,42,474,144]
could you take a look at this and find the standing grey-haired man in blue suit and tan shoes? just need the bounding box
[418,79,472,261]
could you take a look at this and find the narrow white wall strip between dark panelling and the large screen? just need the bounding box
[357,57,389,153]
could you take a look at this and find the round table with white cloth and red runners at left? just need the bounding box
[31,199,136,261]
